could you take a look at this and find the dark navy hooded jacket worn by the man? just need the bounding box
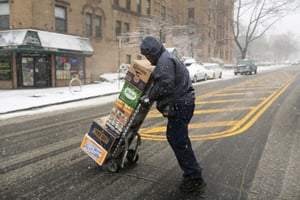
[141,36,195,112]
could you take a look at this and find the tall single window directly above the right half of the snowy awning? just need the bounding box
[55,6,67,33]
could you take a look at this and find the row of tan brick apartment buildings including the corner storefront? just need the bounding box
[0,0,233,88]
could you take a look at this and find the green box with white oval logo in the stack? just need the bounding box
[119,82,142,109]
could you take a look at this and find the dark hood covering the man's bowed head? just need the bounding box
[140,36,165,65]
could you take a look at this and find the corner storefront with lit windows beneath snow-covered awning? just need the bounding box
[0,29,93,89]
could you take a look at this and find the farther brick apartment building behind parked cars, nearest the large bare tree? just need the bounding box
[172,0,234,63]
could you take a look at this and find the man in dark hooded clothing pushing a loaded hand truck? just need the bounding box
[140,36,206,192]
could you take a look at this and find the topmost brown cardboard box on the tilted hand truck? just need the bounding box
[125,60,154,91]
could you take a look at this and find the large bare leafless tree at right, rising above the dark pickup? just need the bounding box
[231,0,300,59]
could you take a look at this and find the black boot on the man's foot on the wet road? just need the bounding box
[180,178,206,192]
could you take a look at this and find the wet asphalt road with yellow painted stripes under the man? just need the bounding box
[0,67,300,200]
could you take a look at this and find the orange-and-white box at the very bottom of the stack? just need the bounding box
[80,134,107,166]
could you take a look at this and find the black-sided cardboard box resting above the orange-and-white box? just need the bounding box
[88,118,120,152]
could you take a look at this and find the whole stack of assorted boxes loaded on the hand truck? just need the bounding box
[81,60,154,165]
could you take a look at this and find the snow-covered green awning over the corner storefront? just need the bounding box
[0,29,94,56]
